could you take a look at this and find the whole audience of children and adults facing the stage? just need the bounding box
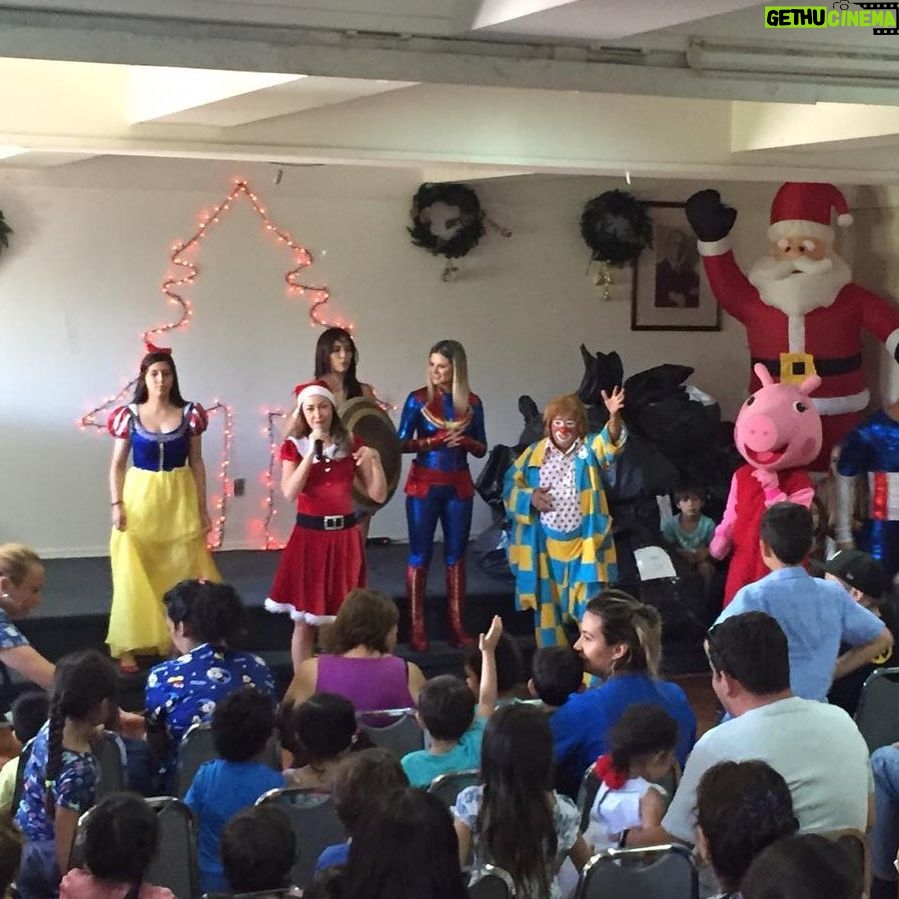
[0,500,899,899]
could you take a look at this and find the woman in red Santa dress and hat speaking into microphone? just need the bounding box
[265,381,387,671]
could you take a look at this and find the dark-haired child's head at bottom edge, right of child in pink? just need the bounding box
[221,805,299,897]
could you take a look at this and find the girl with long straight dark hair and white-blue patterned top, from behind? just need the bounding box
[452,704,590,899]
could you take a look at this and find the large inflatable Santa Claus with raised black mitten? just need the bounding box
[686,182,899,471]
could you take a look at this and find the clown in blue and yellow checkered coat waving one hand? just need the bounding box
[503,387,627,647]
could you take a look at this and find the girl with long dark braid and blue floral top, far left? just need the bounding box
[16,650,117,899]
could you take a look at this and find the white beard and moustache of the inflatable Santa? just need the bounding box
[747,253,852,315]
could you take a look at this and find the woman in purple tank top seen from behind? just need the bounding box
[284,588,425,712]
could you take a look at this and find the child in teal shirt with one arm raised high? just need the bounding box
[402,615,503,787]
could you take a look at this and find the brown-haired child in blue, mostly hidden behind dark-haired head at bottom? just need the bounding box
[315,748,409,871]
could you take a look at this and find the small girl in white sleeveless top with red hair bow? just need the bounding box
[584,703,677,851]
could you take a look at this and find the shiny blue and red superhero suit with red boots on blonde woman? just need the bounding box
[397,387,487,651]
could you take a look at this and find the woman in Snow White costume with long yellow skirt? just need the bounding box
[106,343,221,673]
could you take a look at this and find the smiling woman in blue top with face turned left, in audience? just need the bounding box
[550,590,696,797]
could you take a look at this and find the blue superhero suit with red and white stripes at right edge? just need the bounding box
[837,410,899,588]
